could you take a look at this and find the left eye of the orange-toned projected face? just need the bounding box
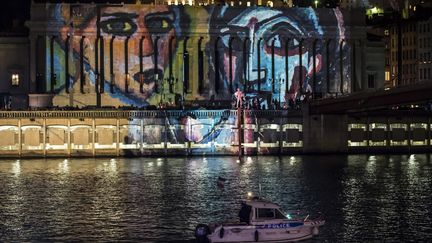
[100,18,137,36]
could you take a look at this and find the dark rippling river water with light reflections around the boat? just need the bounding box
[0,154,432,242]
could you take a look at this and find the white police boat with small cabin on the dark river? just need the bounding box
[195,197,325,243]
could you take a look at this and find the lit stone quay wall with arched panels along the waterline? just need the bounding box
[0,106,432,158]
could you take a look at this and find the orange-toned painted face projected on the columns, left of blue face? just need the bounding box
[64,5,179,103]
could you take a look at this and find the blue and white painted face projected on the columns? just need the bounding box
[221,9,322,102]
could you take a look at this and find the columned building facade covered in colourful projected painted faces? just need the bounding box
[28,3,365,108]
